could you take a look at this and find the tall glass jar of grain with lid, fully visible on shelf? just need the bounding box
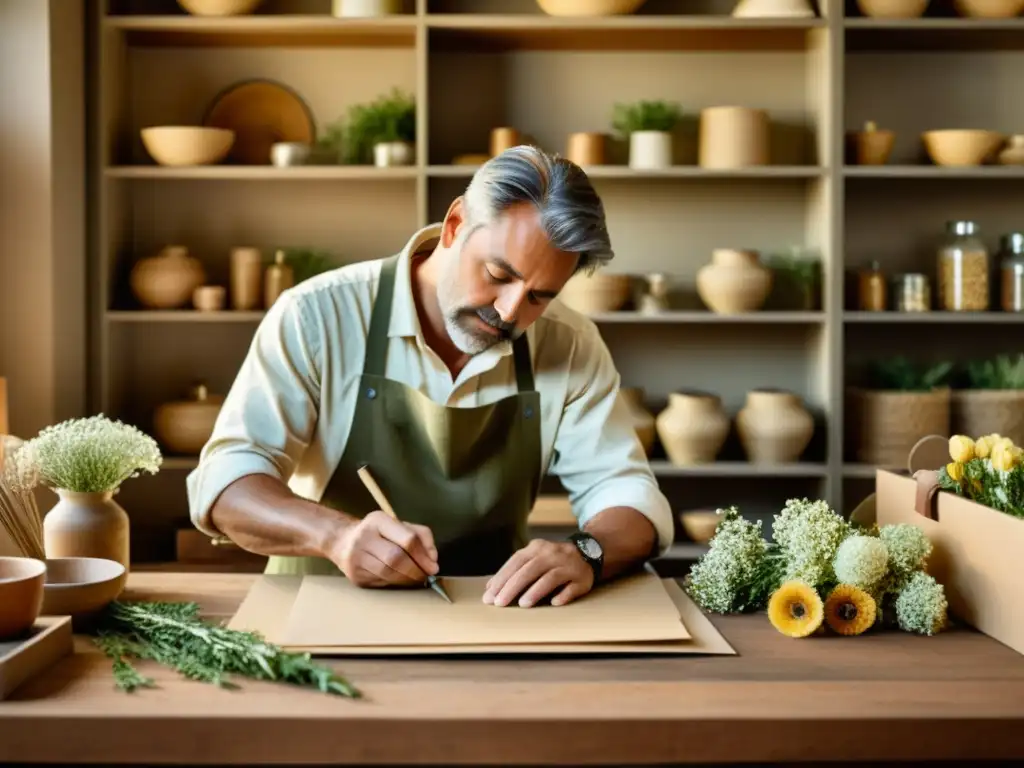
[937,221,989,312]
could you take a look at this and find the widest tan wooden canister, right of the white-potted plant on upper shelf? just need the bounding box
[698,106,771,168]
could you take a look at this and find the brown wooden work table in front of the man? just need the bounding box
[0,573,1024,765]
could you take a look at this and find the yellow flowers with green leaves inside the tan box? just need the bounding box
[939,434,1024,518]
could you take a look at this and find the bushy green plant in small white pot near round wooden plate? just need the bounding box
[344,89,416,168]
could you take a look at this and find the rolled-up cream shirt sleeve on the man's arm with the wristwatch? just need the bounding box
[550,324,675,554]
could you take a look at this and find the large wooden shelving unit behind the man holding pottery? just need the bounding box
[83,0,1024,560]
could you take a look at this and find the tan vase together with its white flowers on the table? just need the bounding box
[30,414,163,568]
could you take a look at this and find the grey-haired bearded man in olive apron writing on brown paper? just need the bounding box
[188,146,673,606]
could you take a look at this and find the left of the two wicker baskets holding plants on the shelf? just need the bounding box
[847,387,950,467]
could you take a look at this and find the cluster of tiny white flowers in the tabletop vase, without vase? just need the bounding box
[30,414,163,494]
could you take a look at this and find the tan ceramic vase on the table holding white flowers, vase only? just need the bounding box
[43,489,130,569]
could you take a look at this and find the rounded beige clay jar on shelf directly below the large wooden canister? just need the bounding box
[697,248,772,314]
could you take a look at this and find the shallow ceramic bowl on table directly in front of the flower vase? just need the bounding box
[42,557,128,620]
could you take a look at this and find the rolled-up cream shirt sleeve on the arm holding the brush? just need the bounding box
[186,290,323,537]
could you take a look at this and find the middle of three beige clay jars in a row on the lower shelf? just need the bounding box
[654,390,729,467]
